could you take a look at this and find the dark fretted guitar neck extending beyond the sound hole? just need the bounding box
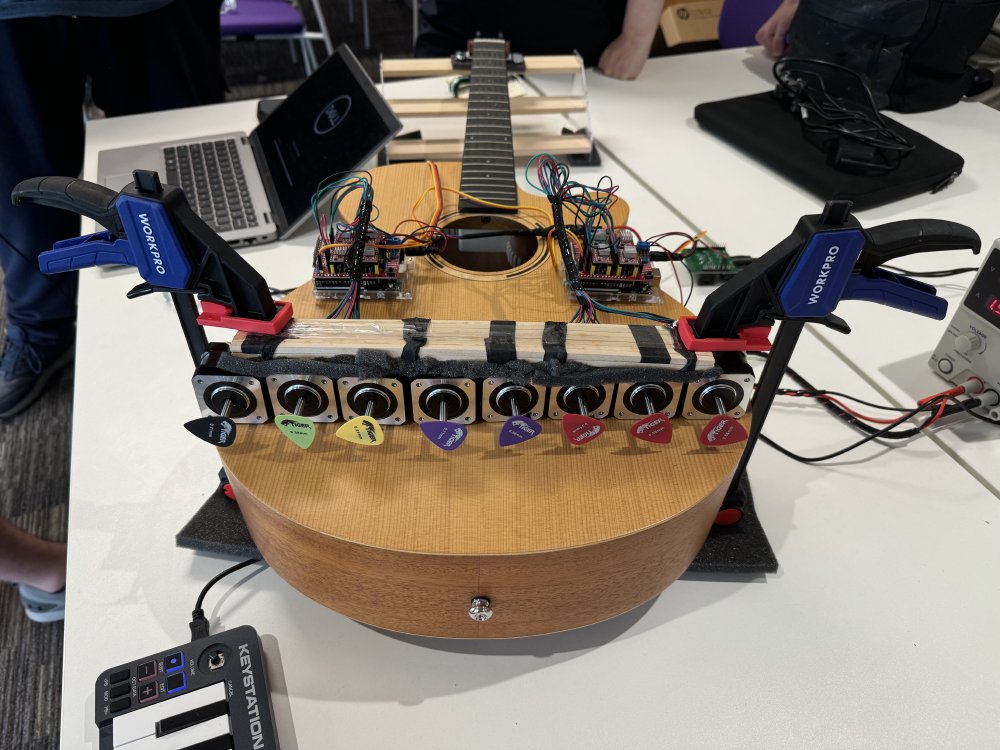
[458,39,517,213]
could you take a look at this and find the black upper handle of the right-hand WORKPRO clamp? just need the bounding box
[855,219,982,273]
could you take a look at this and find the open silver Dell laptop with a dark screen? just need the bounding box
[97,45,402,247]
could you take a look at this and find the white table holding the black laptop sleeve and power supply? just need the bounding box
[535,47,1000,497]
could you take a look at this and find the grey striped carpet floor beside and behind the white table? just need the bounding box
[0,0,413,750]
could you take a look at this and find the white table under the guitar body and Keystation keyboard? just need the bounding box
[62,67,1000,750]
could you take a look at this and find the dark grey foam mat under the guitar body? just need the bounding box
[176,477,778,575]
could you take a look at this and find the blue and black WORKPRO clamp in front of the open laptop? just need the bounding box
[11,170,292,362]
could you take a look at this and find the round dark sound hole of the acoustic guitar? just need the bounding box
[439,216,539,273]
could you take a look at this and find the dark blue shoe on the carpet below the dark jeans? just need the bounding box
[0,328,74,419]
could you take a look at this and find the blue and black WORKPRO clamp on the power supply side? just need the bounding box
[677,201,981,524]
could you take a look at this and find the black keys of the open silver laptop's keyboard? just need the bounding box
[163,138,258,232]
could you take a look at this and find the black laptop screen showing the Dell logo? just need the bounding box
[252,45,402,233]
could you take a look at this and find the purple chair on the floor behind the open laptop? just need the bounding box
[219,0,333,76]
